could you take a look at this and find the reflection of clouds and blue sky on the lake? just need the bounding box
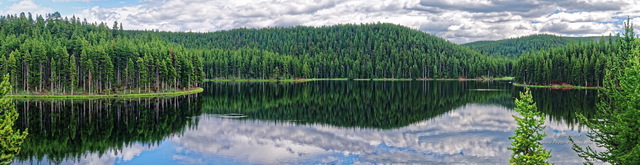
[15,104,604,164]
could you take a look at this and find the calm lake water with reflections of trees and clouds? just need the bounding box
[15,81,597,164]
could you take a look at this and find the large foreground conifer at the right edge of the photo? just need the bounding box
[573,18,640,164]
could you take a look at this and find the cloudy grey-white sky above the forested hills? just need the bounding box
[0,0,640,44]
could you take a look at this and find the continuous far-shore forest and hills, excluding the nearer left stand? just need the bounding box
[125,23,625,86]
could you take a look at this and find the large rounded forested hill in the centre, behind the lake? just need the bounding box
[129,23,512,78]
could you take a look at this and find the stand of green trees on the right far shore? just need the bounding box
[513,37,620,86]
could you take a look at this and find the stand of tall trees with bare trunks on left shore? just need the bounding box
[0,12,203,94]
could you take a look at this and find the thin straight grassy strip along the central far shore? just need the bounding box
[205,77,513,82]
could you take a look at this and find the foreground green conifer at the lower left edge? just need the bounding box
[0,74,28,164]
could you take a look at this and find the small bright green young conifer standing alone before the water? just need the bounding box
[509,88,551,164]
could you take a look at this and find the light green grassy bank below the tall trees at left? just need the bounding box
[7,88,204,99]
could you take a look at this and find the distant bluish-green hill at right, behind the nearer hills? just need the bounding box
[462,34,602,59]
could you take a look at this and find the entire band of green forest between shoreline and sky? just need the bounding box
[0,12,636,94]
